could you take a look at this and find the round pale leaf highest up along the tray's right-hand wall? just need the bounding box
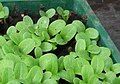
[85,28,99,39]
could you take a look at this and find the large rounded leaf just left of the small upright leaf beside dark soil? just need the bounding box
[18,38,35,54]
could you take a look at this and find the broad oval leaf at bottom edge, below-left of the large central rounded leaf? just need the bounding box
[26,66,43,84]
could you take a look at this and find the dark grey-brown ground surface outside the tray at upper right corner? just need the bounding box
[88,0,120,51]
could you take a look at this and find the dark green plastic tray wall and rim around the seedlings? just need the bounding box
[0,0,120,63]
